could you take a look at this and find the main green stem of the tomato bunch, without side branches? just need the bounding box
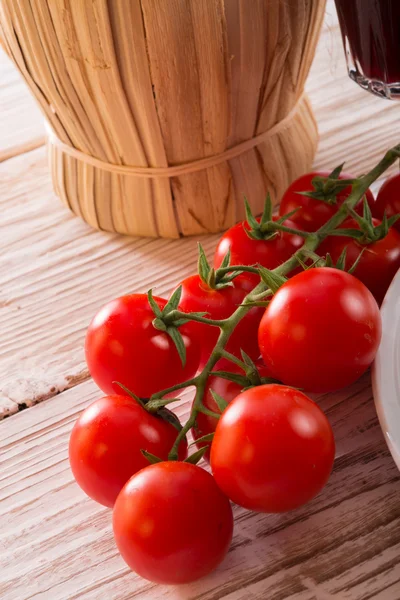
[168,145,400,460]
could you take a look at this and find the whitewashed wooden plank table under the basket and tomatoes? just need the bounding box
[0,6,400,600]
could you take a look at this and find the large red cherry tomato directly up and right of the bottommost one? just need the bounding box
[211,384,335,512]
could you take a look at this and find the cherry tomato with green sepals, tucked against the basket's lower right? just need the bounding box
[278,169,375,233]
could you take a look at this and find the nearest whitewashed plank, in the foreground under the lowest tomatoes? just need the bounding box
[0,374,400,600]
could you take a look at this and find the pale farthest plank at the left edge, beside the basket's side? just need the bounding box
[0,46,45,162]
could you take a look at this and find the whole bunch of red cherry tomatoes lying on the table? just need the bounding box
[69,168,400,584]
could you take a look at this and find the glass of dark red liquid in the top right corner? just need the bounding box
[335,0,400,100]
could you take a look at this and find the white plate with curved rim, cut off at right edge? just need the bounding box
[372,270,400,469]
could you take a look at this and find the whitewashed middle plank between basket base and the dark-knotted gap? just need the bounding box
[0,148,217,414]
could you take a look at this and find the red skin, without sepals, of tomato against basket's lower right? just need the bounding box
[279,171,374,231]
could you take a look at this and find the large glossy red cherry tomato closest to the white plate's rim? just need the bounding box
[258,268,381,392]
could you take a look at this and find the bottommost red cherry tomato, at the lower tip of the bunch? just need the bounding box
[113,462,233,584]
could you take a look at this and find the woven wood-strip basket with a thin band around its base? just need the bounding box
[0,0,325,237]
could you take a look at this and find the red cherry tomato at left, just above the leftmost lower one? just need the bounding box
[85,294,200,398]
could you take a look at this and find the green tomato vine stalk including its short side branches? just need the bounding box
[151,145,400,460]
